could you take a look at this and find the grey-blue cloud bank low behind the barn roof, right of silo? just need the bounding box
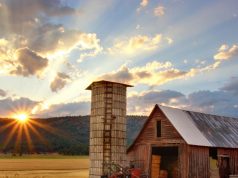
[128,86,238,117]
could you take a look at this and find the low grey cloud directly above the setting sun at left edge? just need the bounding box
[0,97,39,117]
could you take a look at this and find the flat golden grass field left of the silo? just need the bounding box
[0,155,89,178]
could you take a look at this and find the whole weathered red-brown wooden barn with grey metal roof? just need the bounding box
[127,105,238,178]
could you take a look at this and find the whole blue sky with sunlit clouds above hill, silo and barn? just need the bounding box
[0,0,238,118]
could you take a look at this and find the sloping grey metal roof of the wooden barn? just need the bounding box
[129,105,238,149]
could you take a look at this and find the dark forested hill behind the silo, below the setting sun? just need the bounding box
[0,116,147,155]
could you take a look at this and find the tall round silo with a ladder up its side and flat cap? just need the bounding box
[87,80,131,178]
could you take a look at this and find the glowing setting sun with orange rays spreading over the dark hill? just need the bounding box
[0,109,67,153]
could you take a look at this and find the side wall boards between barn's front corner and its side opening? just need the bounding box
[188,146,210,178]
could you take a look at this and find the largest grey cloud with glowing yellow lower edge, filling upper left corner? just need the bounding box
[0,0,102,61]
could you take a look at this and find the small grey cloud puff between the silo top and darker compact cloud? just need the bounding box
[50,72,70,92]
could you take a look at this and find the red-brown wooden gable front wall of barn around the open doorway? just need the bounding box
[127,106,187,174]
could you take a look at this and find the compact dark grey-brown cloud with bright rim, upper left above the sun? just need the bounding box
[10,48,48,76]
